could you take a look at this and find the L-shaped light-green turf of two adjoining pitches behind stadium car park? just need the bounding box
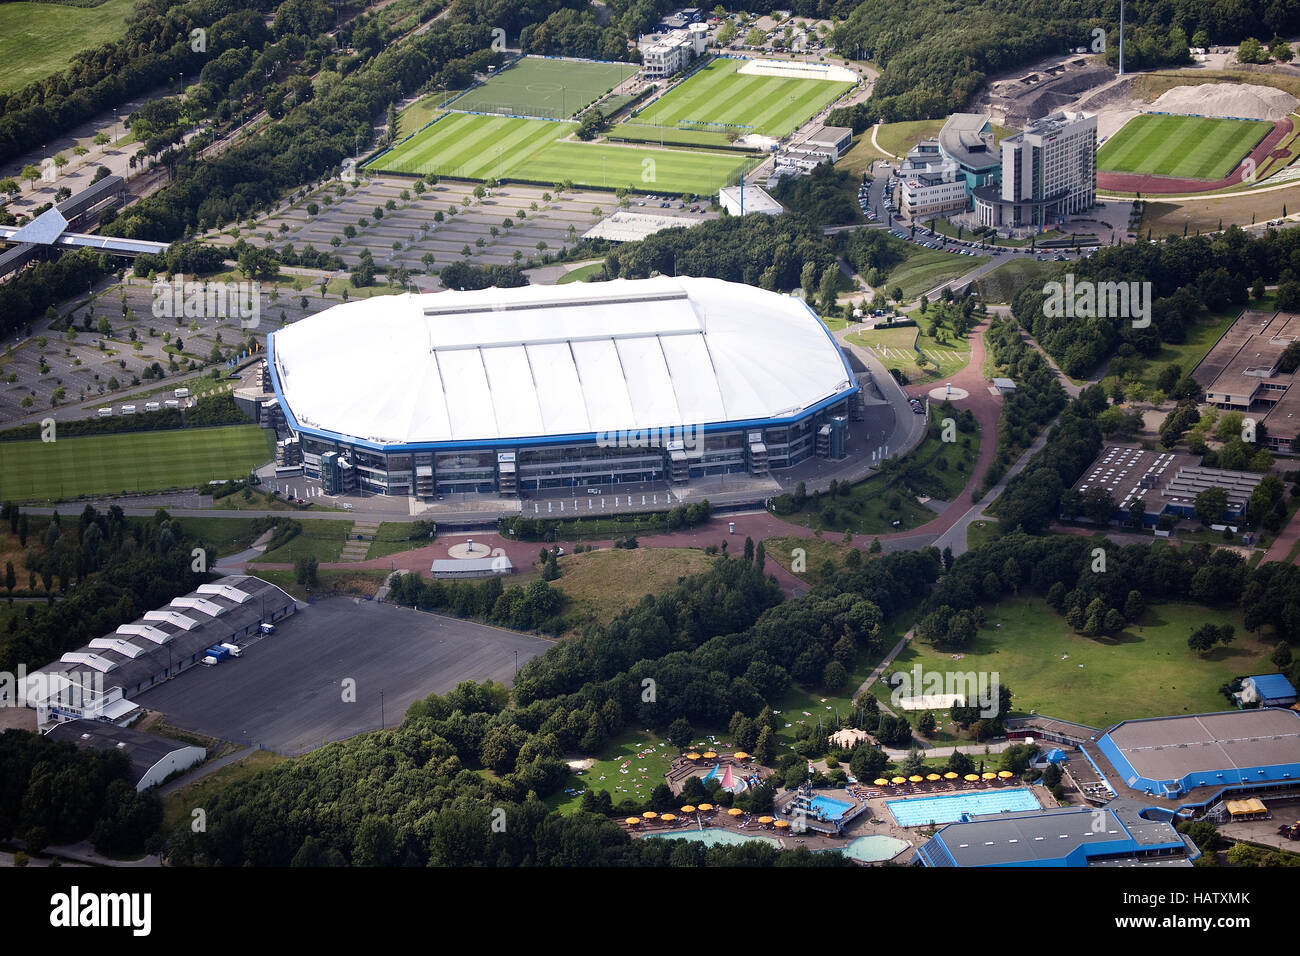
[369,113,755,195]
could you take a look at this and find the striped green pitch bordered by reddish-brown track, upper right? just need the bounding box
[1097,113,1273,179]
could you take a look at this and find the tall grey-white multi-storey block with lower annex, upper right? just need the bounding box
[972,112,1097,229]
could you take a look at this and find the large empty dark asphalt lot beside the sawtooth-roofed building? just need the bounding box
[134,597,551,756]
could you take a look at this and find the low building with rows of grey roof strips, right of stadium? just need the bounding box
[1062,445,1264,525]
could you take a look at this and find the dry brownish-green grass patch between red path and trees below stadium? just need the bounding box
[546,545,716,631]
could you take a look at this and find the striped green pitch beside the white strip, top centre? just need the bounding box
[621,59,852,137]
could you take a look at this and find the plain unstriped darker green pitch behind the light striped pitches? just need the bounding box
[452,56,637,120]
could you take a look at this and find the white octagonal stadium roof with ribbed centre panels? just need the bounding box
[272,277,854,445]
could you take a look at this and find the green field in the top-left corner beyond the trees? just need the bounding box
[0,0,135,92]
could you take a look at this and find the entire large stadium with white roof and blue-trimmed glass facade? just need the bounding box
[268,277,858,498]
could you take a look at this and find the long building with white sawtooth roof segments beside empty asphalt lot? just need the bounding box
[18,575,296,726]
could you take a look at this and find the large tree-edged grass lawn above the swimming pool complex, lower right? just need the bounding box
[894,598,1273,727]
